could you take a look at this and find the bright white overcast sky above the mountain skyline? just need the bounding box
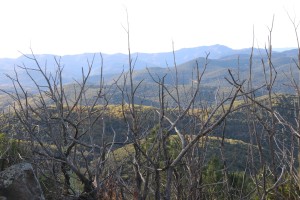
[0,0,300,58]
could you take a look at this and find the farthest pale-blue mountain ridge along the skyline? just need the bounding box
[0,44,297,86]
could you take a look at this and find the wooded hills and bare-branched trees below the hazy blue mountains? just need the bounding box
[0,20,300,200]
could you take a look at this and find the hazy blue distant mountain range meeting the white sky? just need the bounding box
[0,45,297,87]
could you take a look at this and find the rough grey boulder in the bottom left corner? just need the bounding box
[0,163,45,200]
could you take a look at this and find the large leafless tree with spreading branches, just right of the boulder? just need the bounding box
[4,53,121,199]
